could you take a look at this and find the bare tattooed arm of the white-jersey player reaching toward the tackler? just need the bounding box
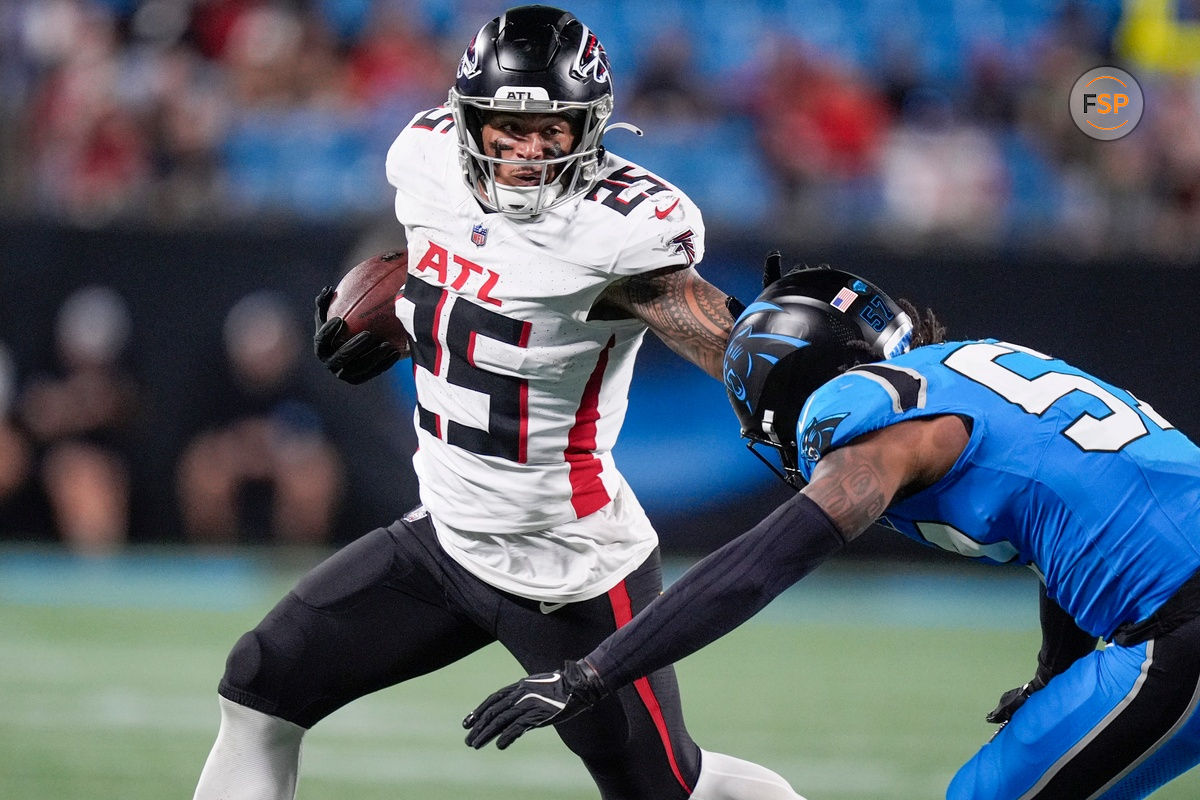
[612,269,733,379]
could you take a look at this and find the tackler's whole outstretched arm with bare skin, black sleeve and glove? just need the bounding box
[463,416,968,748]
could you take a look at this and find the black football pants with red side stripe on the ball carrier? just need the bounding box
[218,515,700,800]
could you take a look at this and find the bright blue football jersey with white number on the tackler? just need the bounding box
[797,339,1200,638]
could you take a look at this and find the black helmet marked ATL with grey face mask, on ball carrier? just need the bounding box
[448,6,613,217]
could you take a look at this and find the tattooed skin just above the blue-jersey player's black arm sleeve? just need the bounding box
[804,446,893,540]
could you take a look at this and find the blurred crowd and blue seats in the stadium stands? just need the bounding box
[0,0,1200,259]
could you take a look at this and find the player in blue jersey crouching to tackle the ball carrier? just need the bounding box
[464,270,1200,800]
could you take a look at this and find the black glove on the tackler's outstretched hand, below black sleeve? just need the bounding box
[462,660,608,750]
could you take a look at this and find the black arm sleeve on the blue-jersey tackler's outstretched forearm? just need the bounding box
[584,494,846,691]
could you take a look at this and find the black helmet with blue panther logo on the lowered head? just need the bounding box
[724,267,913,488]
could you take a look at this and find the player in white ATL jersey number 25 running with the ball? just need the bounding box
[196,6,798,800]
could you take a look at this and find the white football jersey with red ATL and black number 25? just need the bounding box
[386,108,704,599]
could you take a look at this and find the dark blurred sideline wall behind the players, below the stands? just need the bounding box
[0,224,1200,553]
